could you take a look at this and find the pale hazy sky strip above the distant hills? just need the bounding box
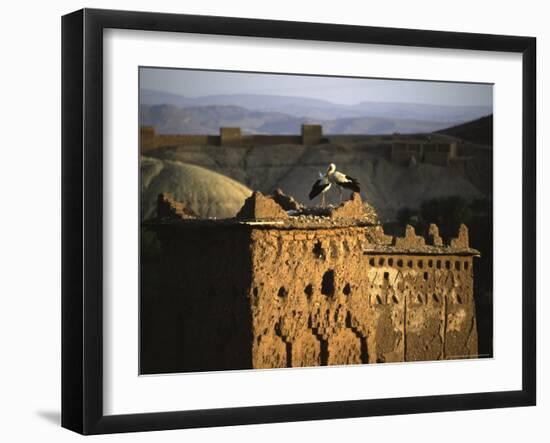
[140,68,493,106]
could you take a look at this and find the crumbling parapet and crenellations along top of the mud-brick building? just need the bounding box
[148,193,479,256]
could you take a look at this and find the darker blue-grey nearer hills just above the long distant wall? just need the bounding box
[140,105,462,134]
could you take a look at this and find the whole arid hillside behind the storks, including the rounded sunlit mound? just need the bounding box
[142,142,484,221]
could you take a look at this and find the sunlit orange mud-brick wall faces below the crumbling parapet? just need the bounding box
[250,228,477,368]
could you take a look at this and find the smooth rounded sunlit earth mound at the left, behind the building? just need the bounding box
[141,156,252,220]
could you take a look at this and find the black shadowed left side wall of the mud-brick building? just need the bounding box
[140,225,252,374]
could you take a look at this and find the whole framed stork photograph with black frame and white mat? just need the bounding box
[62,9,536,434]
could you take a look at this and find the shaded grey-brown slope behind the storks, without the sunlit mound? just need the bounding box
[144,143,482,221]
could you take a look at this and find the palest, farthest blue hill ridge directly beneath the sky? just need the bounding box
[140,89,492,126]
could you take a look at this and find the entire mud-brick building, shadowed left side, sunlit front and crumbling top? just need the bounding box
[146,193,478,372]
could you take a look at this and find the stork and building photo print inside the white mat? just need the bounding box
[139,67,493,374]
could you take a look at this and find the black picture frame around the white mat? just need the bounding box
[62,9,536,434]
